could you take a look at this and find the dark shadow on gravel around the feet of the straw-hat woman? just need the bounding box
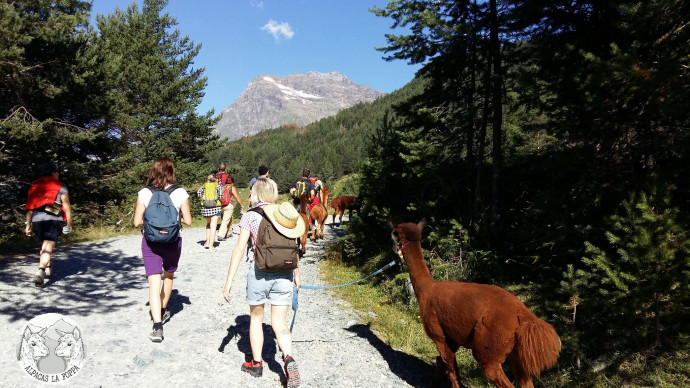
[218,315,285,380]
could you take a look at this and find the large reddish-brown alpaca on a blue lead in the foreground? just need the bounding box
[391,220,561,388]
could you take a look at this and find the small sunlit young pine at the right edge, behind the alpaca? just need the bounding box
[580,186,690,351]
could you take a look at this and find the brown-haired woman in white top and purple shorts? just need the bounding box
[134,158,192,342]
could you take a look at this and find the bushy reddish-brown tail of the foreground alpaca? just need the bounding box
[515,314,561,377]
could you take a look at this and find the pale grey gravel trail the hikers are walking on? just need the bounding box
[0,220,431,387]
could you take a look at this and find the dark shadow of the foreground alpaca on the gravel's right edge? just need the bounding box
[346,324,436,387]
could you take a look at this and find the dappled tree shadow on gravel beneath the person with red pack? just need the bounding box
[0,241,147,322]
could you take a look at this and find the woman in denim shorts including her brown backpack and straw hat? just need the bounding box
[223,178,306,388]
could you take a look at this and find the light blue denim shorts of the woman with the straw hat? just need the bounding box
[247,263,293,306]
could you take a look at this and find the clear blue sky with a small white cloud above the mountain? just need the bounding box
[92,0,419,114]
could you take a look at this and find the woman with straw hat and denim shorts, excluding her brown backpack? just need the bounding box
[223,178,306,388]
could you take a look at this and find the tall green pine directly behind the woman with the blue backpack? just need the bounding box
[92,0,222,195]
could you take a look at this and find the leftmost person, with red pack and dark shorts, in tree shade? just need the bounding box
[24,163,72,287]
